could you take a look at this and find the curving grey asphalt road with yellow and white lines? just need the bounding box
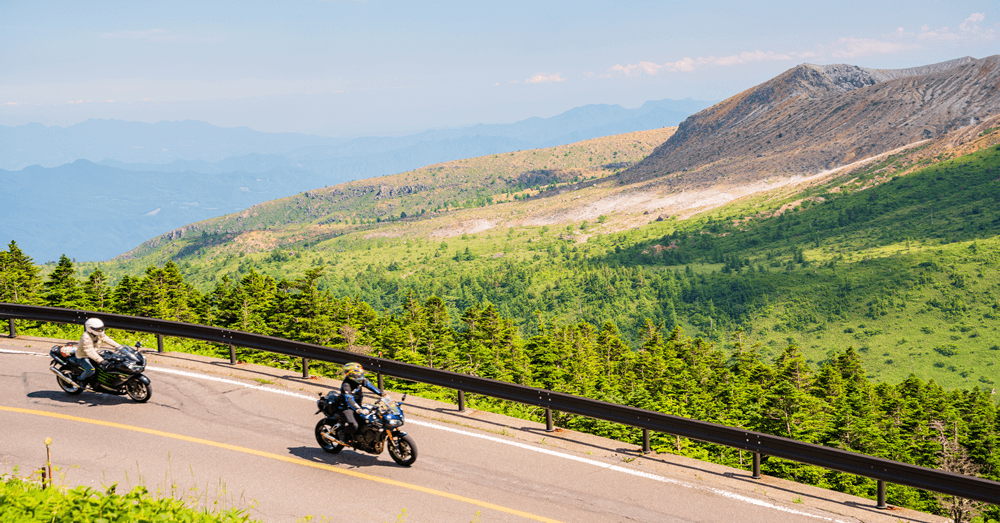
[0,340,938,523]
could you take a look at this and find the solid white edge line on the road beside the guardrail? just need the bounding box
[146,367,849,523]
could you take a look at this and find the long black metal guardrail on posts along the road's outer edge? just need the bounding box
[0,303,1000,508]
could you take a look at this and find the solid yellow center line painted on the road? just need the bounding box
[0,405,560,523]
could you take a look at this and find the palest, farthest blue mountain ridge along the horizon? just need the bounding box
[0,99,711,172]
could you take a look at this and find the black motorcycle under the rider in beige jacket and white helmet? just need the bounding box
[49,343,153,403]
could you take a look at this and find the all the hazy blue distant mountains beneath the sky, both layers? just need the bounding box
[0,99,711,261]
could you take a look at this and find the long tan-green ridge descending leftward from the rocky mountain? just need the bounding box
[113,127,676,270]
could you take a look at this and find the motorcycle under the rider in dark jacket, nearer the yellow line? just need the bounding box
[316,390,417,467]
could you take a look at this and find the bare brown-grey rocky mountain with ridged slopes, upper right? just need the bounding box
[620,56,1000,189]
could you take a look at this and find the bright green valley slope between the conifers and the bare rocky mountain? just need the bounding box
[72,137,1000,388]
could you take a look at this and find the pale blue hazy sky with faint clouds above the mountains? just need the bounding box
[0,0,1000,136]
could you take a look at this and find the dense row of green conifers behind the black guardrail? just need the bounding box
[0,242,1000,519]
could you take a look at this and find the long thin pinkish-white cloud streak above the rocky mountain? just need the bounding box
[601,13,996,78]
